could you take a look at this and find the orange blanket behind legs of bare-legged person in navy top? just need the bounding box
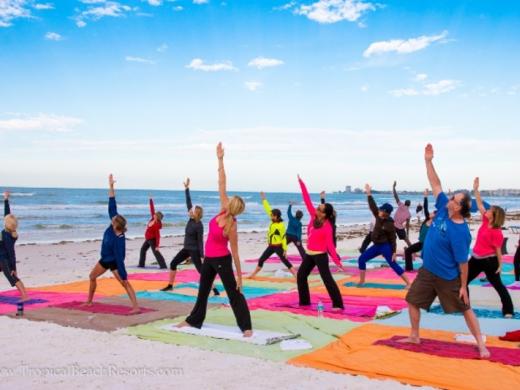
[38,278,165,295]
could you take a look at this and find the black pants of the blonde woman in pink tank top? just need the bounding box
[186,255,252,332]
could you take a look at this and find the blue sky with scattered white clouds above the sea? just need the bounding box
[0,0,520,192]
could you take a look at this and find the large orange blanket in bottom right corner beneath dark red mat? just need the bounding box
[289,324,520,390]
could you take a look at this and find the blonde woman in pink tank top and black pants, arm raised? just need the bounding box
[178,143,253,337]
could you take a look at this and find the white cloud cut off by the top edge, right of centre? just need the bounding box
[294,0,376,24]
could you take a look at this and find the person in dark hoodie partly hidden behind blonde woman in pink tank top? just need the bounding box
[161,178,220,295]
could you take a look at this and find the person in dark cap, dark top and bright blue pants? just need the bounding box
[358,184,410,288]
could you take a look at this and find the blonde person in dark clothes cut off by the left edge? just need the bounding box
[0,192,29,302]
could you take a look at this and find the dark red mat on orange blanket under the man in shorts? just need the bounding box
[374,336,520,366]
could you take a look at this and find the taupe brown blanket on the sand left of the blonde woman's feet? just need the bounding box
[17,297,209,332]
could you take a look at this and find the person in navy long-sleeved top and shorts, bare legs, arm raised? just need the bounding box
[86,174,139,314]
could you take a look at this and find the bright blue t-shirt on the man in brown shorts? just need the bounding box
[422,192,471,280]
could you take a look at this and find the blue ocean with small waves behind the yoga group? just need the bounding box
[2,187,520,243]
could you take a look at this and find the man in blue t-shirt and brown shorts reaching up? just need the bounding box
[401,144,490,358]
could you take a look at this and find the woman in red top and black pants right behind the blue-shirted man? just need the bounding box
[467,177,514,318]
